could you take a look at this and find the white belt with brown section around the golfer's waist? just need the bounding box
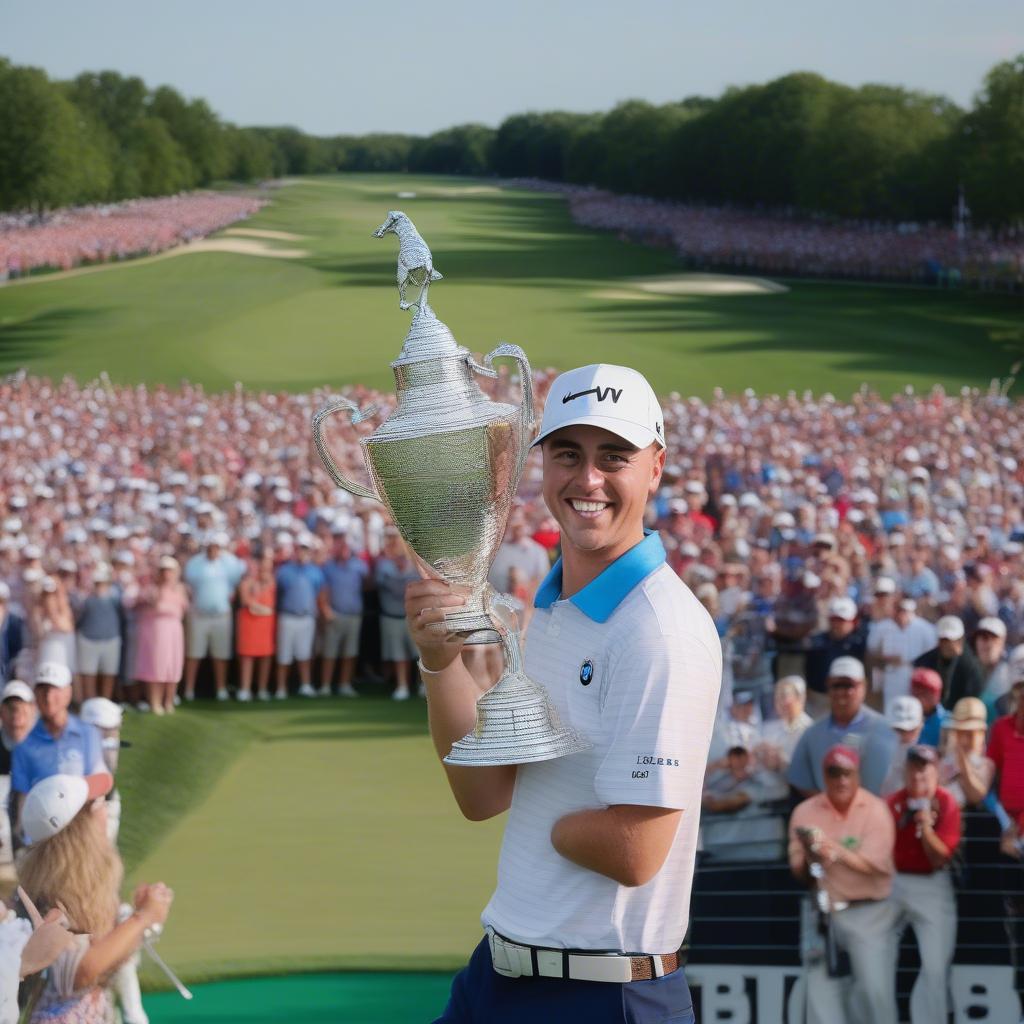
[485,928,679,984]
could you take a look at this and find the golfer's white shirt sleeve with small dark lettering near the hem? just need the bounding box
[594,635,722,810]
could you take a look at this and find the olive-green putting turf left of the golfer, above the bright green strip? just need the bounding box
[121,695,502,983]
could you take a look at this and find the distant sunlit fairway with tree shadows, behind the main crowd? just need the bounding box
[0,175,1024,396]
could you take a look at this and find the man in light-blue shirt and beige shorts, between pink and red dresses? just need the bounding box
[184,531,246,700]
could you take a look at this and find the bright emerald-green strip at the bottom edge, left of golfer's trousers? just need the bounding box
[145,974,451,1024]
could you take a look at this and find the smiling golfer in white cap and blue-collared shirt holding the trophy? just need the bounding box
[407,365,722,1024]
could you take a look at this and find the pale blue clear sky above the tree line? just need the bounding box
[0,0,1024,134]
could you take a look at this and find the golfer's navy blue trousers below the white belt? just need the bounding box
[434,938,694,1024]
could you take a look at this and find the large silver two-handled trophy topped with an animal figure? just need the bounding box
[313,210,590,765]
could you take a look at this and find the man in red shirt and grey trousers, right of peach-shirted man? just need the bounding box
[887,744,961,1021]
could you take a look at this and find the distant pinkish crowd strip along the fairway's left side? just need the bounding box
[0,193,264,282]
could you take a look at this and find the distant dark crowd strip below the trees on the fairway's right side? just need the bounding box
[511,180,1024,290]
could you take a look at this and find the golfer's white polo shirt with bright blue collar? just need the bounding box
[481,534,722,953]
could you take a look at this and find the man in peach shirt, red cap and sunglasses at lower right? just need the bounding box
[790,744,897,1024]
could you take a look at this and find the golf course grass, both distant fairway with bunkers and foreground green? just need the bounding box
[8,174,1024,1024]
